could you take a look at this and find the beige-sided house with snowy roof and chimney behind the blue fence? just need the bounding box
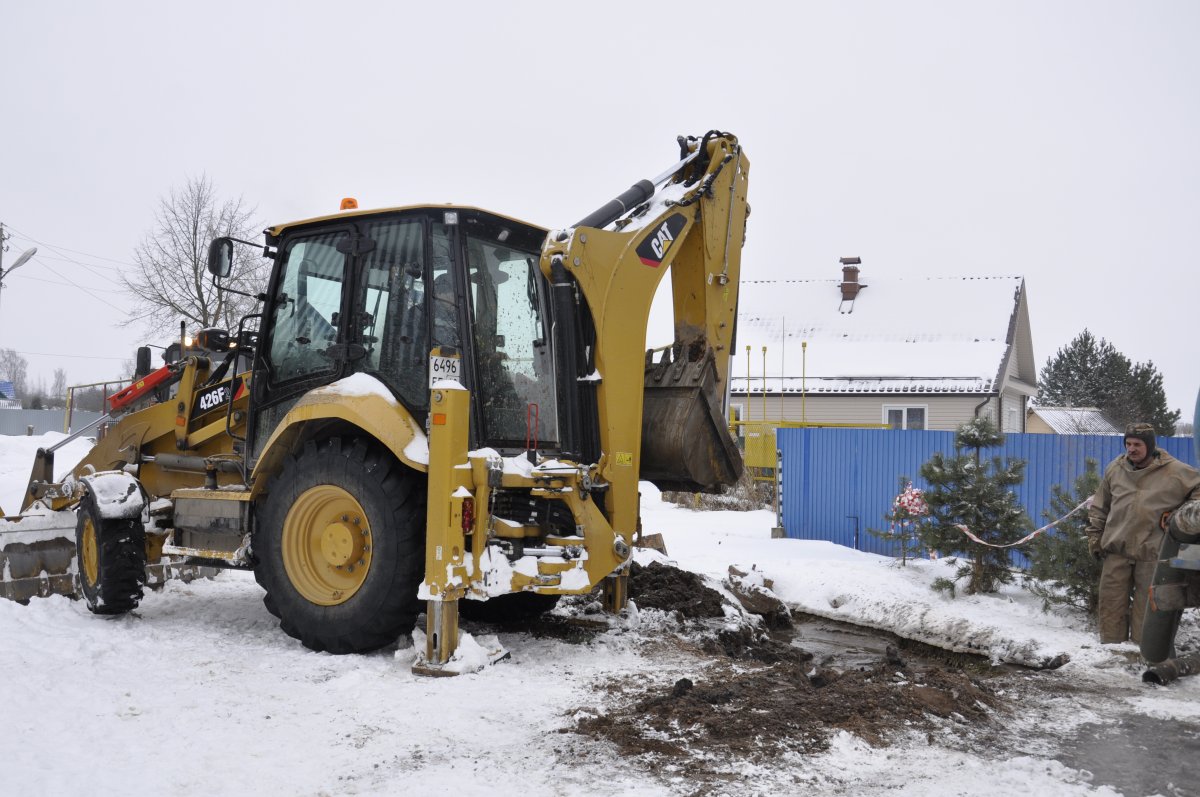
[730,258,1037,432]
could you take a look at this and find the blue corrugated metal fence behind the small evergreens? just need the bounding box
[778,429,1196,565]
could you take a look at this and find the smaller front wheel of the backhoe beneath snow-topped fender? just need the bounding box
[76,491,146,615]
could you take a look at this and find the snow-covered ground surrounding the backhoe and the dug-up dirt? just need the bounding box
[0,435,1200,796]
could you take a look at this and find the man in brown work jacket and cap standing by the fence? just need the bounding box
[1087,424,1200,643]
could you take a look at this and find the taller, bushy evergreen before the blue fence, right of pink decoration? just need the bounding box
[917,418,1030,595]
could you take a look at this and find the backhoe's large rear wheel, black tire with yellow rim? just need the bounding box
[253,437,425,654]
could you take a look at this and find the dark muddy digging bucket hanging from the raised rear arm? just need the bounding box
[642,347,742,492]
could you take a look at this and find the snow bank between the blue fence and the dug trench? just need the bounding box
[642,483,1190,669]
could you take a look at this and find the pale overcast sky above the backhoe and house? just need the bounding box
[0,0,1200,420]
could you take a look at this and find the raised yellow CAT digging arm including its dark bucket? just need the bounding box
[541,132,749,532]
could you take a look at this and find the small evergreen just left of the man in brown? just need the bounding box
[1026,460,1100,616]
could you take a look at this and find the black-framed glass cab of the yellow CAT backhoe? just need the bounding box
[210,206,558,459]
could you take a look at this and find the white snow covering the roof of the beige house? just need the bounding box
[730,277,1022,394]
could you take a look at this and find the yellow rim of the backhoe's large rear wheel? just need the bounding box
[282,485,372,606]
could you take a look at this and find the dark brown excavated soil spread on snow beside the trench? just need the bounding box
[566,564,1003,769]
